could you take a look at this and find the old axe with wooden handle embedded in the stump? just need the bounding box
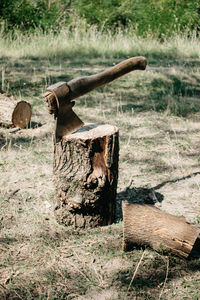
[44,56,147,141]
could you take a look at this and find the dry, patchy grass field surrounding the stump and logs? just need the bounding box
[0,30,200,300]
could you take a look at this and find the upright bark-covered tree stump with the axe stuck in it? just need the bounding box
[53,124,119,228]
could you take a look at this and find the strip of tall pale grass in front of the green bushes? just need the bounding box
[0,27,200,60]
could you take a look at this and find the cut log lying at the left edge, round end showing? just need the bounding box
[0,94,32,128]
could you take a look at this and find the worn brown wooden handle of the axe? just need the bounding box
[67,56,147,100]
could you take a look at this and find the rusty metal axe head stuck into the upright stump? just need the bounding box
[44,82,84,141]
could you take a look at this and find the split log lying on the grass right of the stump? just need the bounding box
[123,201,200,258]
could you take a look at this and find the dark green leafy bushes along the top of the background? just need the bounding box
[0,0,200,39]
